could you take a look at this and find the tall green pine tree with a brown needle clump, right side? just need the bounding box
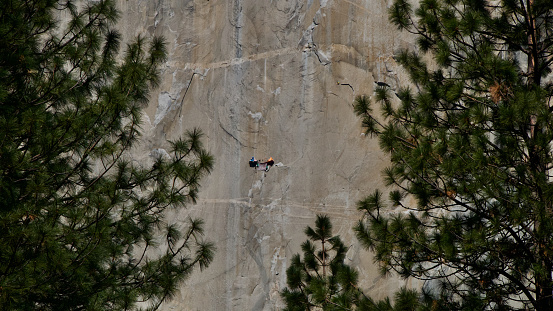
[355,0,553,311]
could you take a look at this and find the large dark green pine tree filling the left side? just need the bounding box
[0,0,214,310]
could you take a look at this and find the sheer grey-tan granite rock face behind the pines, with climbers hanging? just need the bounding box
[114,0,410,310]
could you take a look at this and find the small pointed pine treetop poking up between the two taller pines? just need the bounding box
[281,215,433,311]
